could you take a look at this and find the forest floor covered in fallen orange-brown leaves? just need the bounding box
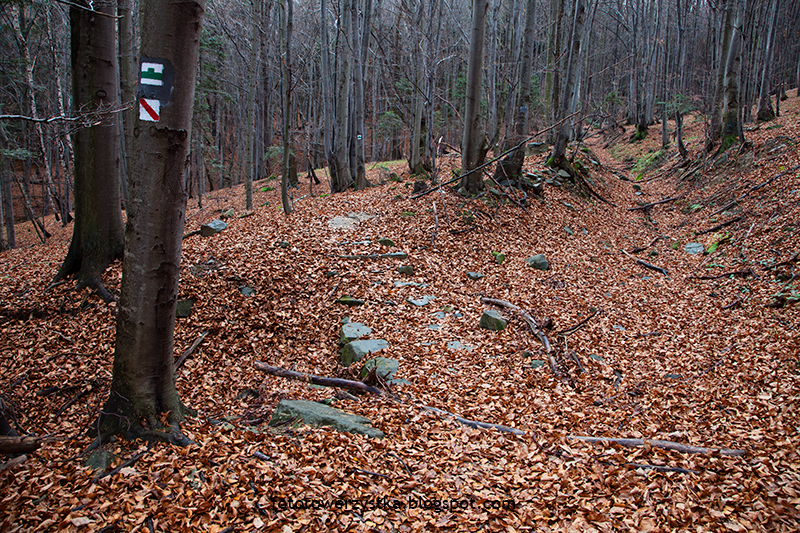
[0,90,800,532]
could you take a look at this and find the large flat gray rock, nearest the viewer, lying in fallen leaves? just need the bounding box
[269,400,383,438]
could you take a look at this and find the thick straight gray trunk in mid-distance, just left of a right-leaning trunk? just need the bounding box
[461,0,489,194]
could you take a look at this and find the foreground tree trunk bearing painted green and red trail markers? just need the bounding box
[99,0,204,444]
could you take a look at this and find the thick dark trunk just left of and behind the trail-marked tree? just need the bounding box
[53,0,124,301]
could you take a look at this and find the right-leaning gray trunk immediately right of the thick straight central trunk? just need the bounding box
[495,0,536,181]
